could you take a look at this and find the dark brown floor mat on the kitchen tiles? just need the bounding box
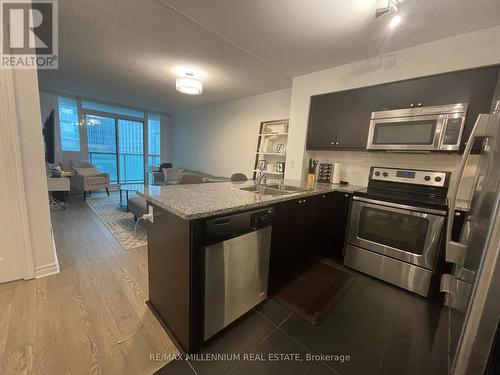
[272,261,355,325]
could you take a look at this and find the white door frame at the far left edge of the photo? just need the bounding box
[0,69,35,279]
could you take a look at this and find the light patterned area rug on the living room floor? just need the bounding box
[86,197,148,250]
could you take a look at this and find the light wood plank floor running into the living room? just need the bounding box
[0,195,178,375]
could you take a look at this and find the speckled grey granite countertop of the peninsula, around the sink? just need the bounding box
[137,180,364,220]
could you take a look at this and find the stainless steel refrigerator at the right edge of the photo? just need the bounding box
[433,101,500,375]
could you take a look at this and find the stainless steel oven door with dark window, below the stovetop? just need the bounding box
[348,197,445,270]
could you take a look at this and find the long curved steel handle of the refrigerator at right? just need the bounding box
[445,114,488,265]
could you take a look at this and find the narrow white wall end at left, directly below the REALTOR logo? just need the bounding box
[12,70,59,276]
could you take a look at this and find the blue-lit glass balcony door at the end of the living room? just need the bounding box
[85,113,144,184]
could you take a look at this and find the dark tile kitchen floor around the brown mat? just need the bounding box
[157,262,447,375]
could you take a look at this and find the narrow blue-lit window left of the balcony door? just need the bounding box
[58,96,80,152]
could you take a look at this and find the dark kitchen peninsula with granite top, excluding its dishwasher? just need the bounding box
[137,181,363,353]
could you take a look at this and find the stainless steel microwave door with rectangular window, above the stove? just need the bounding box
[366,115,446,151]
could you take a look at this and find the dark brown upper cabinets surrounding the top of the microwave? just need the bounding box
[307,66,499,150]
